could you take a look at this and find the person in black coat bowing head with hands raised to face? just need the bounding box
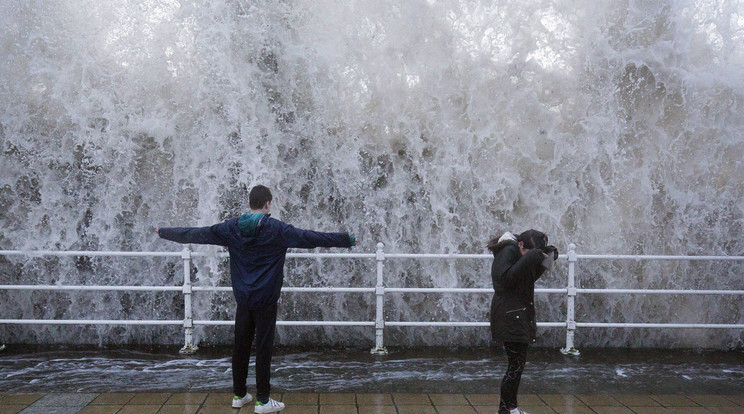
[488,230,558,414]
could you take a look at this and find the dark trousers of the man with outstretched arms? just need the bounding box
[233,303,277,400]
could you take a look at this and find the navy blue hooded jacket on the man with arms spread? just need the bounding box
[158,213,354,310]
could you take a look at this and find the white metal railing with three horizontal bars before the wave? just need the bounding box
[0,243,744,355]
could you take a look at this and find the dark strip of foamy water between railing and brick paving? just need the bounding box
[0,347,744,395]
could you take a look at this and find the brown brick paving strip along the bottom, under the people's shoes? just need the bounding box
[0,393,744,414]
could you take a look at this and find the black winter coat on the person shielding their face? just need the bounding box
[491,240,545,343]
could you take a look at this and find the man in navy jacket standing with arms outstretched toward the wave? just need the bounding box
[157,185,356,413]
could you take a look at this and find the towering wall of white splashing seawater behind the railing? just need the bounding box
[0,0,744,348]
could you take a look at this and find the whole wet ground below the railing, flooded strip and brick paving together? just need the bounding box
[0,346,744,414]
